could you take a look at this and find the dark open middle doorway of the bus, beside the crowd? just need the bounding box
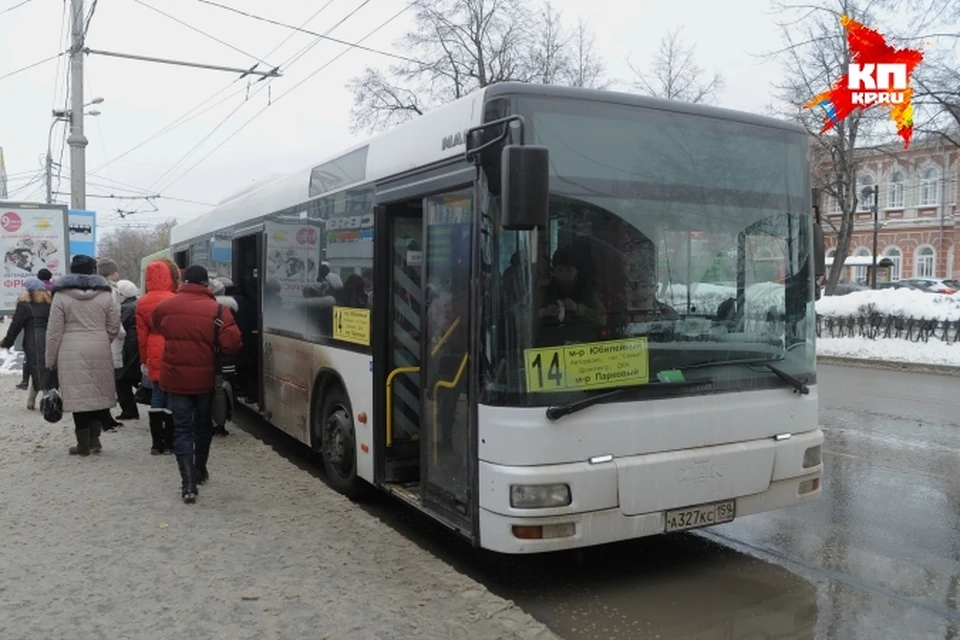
[232,225,263,407]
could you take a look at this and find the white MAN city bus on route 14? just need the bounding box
[171,83,823,553]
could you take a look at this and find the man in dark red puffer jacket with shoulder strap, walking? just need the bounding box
[153,265,243,504]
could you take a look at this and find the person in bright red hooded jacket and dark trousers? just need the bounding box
[137,258,180,455]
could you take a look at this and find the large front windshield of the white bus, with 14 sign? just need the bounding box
[481,99,815,405]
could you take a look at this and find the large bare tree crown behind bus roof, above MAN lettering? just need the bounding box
[347,0,604,132]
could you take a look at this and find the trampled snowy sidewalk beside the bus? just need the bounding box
[0,384,554,640]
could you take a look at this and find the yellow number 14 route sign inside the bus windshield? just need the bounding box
[523,338,650,392]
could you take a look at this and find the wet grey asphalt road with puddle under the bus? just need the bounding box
[232,366,960,640]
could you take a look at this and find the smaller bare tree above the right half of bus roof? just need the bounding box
[627,29,724,102]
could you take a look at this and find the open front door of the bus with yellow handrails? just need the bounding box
[374,172,477,539]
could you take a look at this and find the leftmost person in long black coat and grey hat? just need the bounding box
[0,278,57,411]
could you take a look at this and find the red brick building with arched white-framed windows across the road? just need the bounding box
[814,140,960,280]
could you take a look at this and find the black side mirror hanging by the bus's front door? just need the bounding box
[500,144,550,231]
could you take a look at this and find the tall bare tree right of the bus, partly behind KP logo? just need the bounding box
[774,0,893,295]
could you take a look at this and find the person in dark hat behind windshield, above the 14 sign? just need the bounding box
[540,246,607,344]
